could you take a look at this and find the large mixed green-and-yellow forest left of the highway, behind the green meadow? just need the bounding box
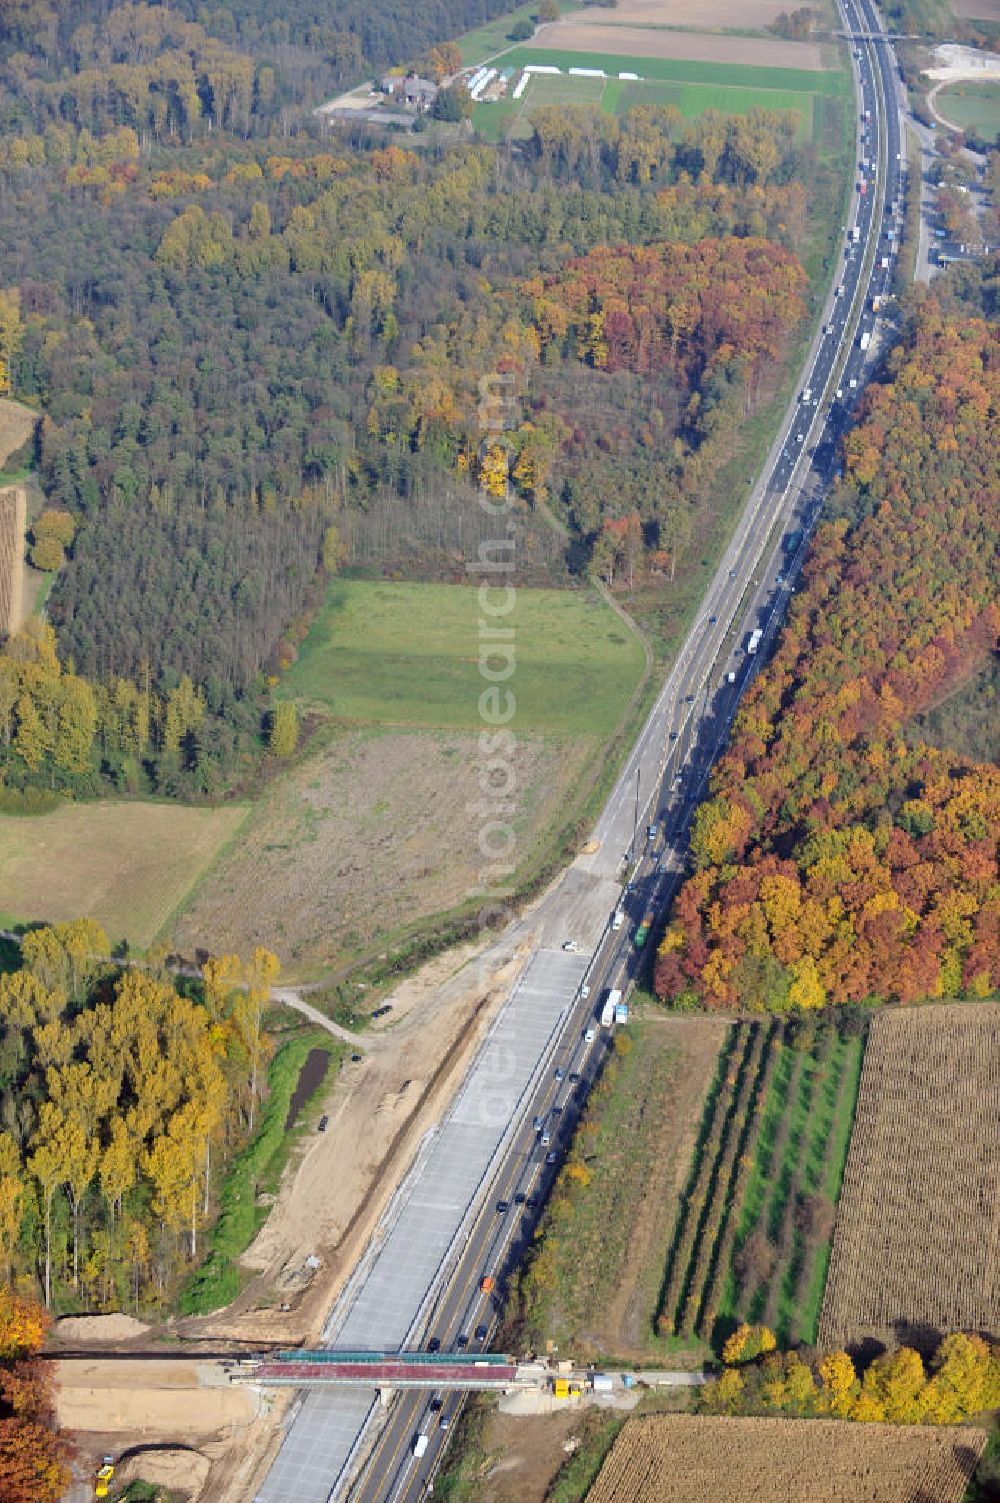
[0,3,824,797]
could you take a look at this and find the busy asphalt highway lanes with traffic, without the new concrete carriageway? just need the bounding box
[258,0,905,1503]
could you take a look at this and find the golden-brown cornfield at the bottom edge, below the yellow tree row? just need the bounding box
[588,1414,986,1503]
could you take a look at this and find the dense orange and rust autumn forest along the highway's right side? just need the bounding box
[656,299,1000,1012]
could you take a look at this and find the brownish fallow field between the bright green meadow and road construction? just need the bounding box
[173,729,595,978]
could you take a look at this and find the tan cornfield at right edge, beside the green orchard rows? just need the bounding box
[820,1004,1000,1348]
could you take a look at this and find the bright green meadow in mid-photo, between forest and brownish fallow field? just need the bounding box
[278,580,645,736]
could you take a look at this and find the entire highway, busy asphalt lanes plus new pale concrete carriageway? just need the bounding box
[257,0,904,1503]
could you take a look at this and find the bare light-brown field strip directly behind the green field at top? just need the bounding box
[526,21,824,74]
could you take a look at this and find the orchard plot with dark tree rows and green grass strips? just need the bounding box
[659,1019,863,1351]
